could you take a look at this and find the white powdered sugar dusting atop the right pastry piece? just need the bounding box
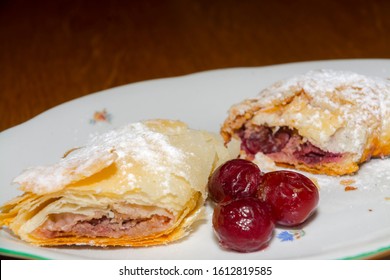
[258,69,390,120]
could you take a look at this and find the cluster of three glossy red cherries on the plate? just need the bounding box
[208,159,319,252]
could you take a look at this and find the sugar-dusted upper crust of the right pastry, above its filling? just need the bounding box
[221,69,390,175]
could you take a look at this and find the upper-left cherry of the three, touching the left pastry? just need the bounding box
[207,159,262,203]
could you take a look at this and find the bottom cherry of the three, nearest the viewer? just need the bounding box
[213,197,275,252]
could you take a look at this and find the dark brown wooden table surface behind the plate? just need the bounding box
[0,0,390,260]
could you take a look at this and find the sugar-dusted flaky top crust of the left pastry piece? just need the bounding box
[14,120,227,210]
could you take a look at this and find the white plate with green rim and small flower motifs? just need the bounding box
[0,59,390,259]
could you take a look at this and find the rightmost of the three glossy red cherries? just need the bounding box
[258,170,319,226]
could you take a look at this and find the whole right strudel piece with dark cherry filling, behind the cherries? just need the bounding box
[221,69,390,175]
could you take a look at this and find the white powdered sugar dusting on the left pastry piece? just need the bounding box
[14,123,185,194]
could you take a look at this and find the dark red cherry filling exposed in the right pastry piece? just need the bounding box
[238,126,342,165]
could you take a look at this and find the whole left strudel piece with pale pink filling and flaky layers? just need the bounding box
[0,120,230,246]
